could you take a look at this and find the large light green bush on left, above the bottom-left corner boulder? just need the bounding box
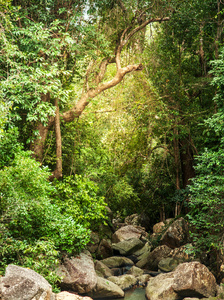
[0,152,89,283]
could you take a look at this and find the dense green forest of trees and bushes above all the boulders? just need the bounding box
[0,0,224,290]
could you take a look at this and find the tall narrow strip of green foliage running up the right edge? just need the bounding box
[189,50,224,258]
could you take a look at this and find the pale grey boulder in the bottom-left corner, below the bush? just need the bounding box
[0,265,53,300]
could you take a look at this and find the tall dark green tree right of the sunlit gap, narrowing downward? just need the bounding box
[146,0,221,204]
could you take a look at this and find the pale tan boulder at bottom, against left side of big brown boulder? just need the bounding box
[145,272,179,300]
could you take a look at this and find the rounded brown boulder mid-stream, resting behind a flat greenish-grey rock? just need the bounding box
[112,225,147,243]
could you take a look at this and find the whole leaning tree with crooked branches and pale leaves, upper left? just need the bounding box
[1,0,169,178]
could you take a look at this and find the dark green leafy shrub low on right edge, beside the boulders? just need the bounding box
[188,147,224,252]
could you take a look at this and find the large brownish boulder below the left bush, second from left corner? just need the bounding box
[57,251,97,294]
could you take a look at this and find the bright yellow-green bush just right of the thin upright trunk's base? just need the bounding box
[54,175,106,230]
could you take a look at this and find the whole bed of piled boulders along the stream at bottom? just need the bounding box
[0,215,224,300]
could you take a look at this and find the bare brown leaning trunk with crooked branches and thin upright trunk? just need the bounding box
[32,17,169,177]
